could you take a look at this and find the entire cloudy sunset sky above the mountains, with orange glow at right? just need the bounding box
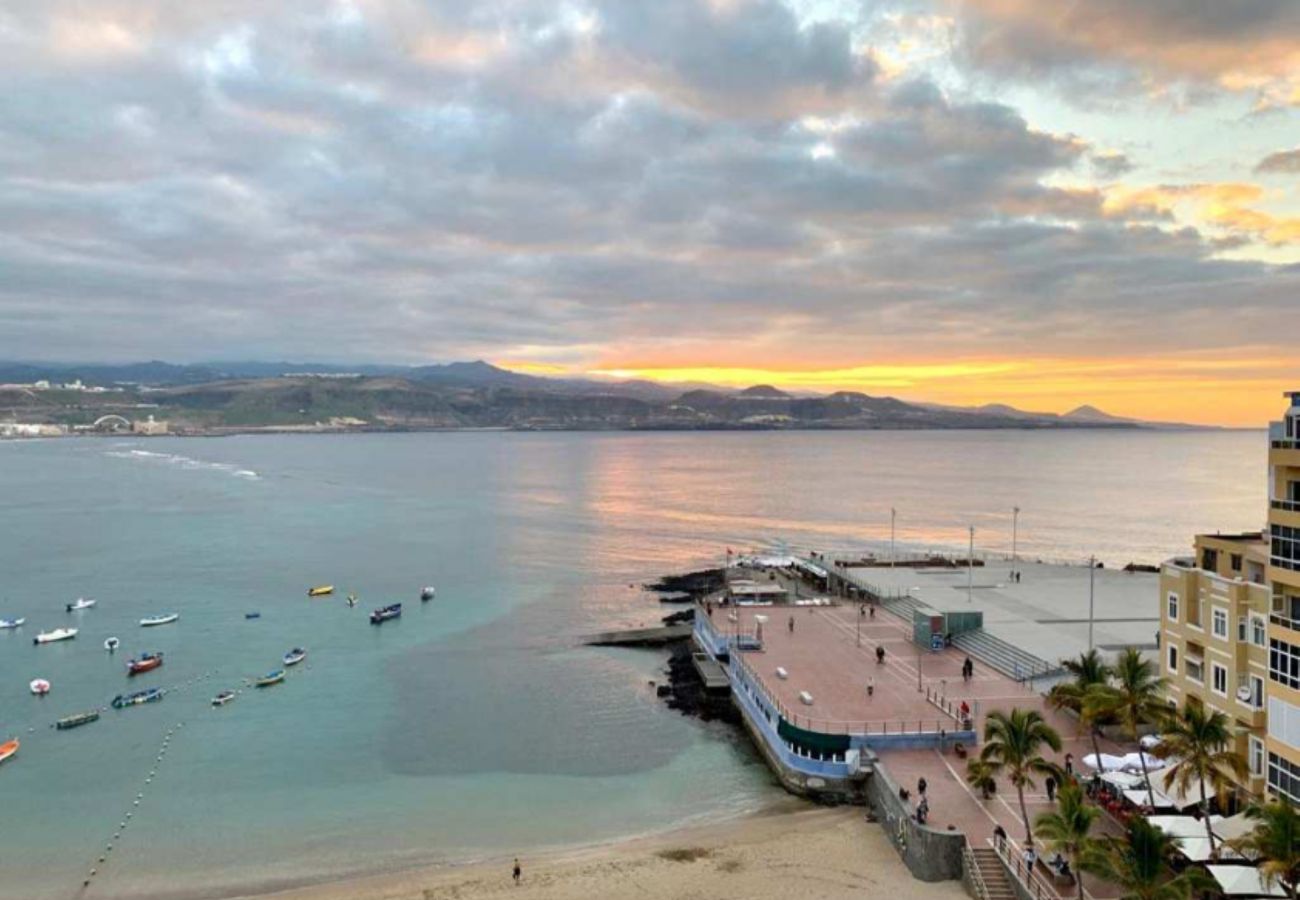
[0,0,1300,425]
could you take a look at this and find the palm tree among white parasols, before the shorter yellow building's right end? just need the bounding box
[1153,700,1248,860]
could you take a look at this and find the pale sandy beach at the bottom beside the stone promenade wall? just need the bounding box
[226,804,965,900]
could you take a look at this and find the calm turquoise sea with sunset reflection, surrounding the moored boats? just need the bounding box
[0,430,1266,900]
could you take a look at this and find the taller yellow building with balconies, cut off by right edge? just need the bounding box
[1265,391,1300,802]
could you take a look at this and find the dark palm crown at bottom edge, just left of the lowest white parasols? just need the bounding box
[1080,815,1214,900]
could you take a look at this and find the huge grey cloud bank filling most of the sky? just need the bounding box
[0,0,1300,362]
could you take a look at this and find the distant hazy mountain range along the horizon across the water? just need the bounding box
[0,360,1216,433]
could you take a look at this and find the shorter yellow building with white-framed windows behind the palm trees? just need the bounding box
[1160,532,1271,795]
